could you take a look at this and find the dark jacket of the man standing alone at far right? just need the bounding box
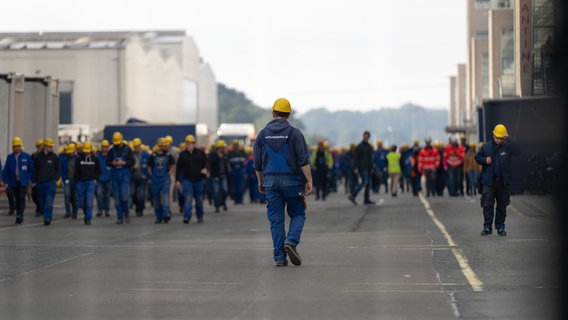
[475,139,521,186]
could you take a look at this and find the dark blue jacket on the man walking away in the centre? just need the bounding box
[253,119,310,176]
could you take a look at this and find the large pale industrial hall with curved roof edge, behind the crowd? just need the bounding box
[0,30,218,143]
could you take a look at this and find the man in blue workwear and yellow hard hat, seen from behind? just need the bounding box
[253,98,313,267]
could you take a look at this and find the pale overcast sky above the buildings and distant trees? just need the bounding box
[0,0,466,111]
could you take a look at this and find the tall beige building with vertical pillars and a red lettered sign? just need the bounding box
[446,0,557,140]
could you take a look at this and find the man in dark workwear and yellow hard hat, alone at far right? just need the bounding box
[475,124,521,236]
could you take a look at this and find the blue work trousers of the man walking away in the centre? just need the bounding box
[263,176,306,262]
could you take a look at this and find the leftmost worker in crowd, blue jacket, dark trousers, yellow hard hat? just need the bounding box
[2,137,33,224]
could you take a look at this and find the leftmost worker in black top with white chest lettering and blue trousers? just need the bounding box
[75,141,101,225]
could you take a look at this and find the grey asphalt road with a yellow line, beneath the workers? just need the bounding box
[0,188,560,319]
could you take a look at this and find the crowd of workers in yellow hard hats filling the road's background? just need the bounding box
[0,125,510,235]
